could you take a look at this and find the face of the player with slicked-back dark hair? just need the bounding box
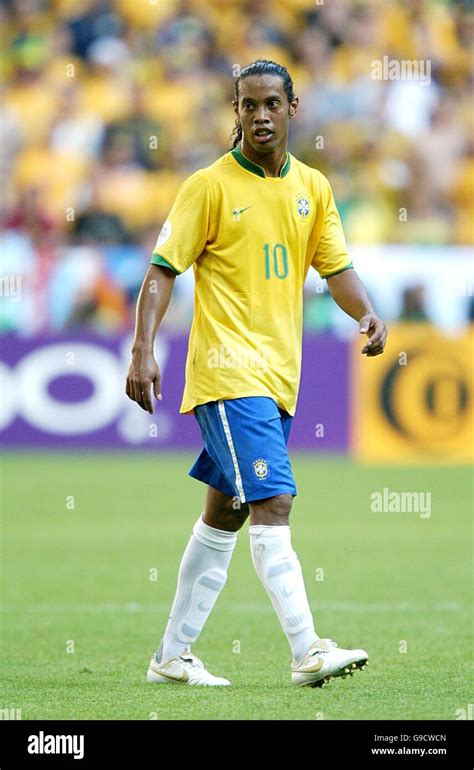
[234,75,298,153]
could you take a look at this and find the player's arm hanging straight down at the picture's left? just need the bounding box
[125,265,176,414]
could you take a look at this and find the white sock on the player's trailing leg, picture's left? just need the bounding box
[157,513,237,662]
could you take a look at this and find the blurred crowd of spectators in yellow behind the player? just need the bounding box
[0,0,474,334]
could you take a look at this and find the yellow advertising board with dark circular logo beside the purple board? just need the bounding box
[351,323,474,463]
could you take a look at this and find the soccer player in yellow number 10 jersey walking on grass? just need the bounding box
[126,60,387,687]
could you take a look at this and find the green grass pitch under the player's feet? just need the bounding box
[0,454,472,720]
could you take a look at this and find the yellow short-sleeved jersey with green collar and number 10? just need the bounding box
[151,146,352,415]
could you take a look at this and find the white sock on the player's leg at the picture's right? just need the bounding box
[249,524,319,663]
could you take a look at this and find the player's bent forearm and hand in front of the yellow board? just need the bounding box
[327,268,387,356]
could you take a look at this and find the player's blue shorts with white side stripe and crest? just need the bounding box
[189,396,296,503]
